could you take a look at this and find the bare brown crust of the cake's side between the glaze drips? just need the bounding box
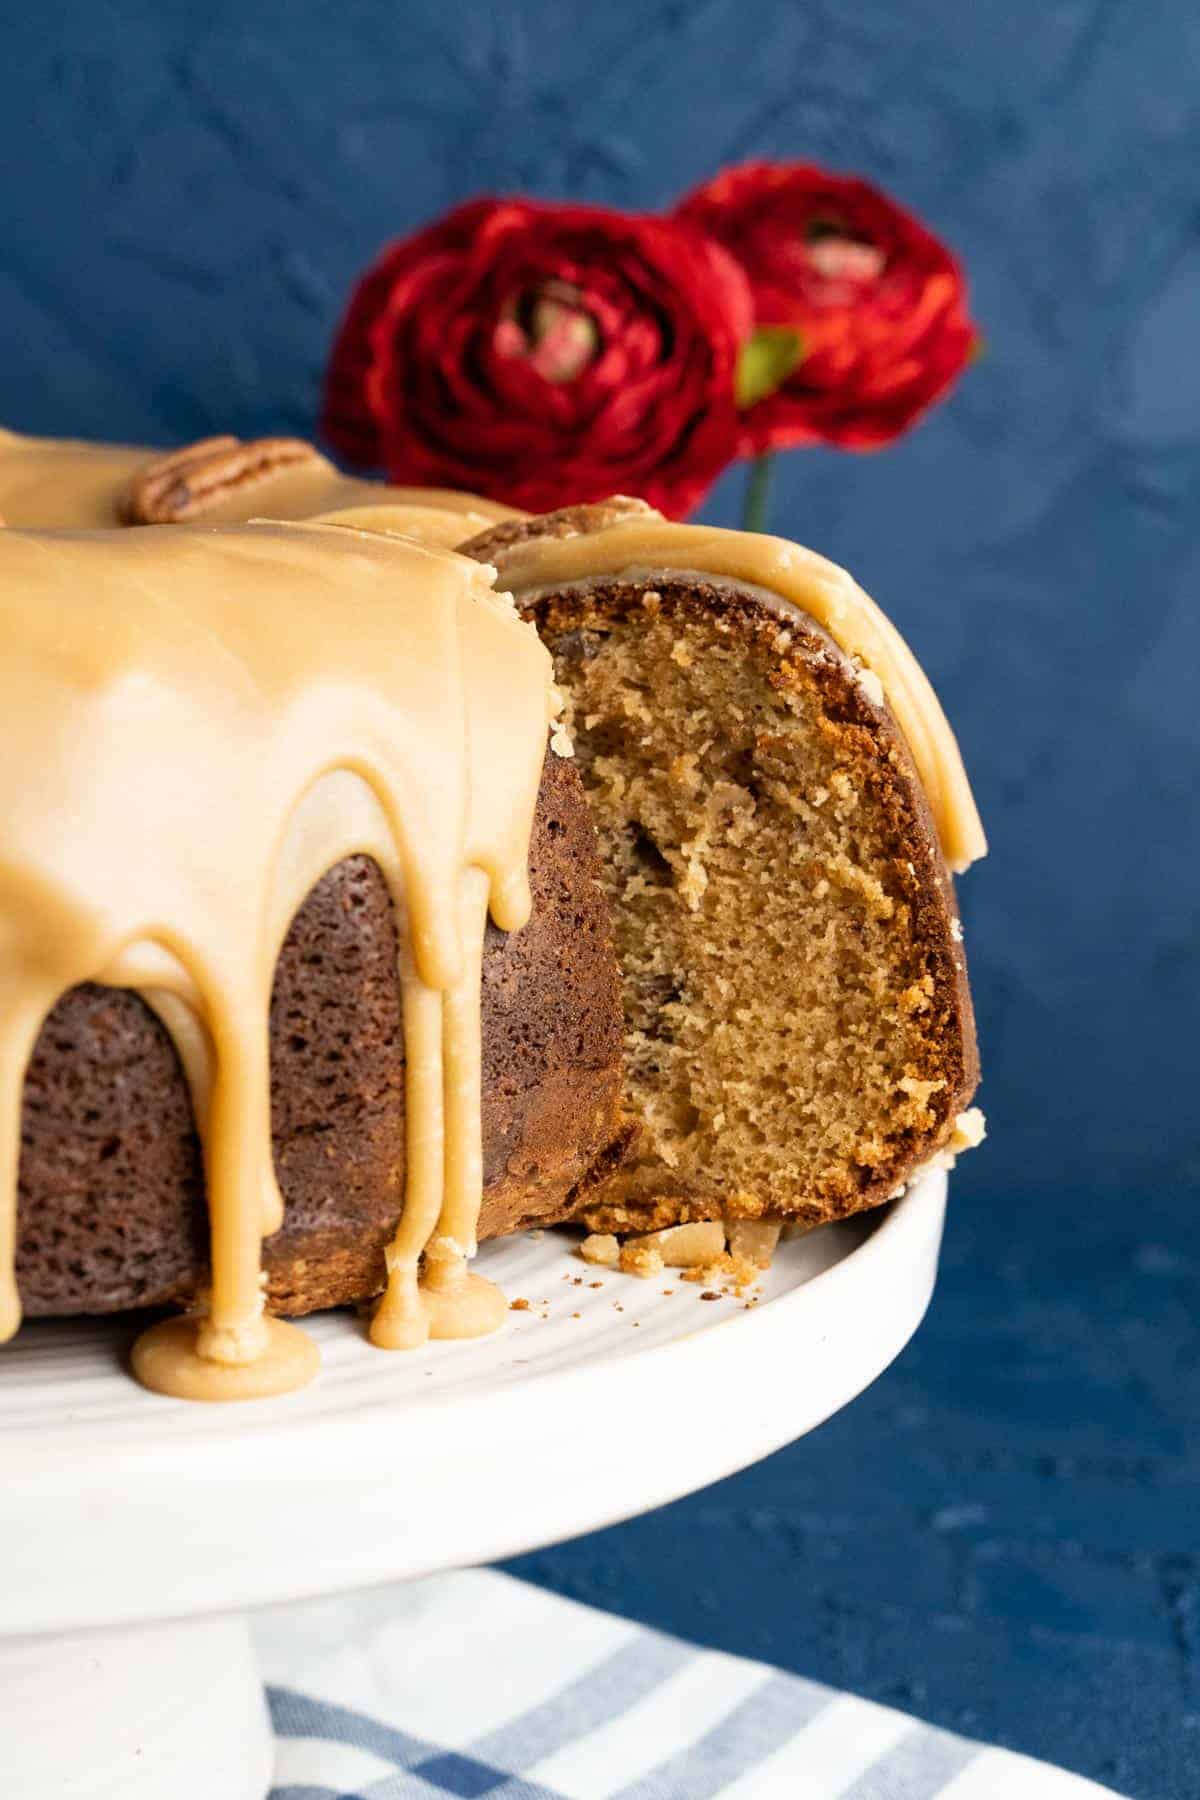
[18,754,628,1316]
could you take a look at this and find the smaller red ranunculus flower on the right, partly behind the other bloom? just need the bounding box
[676,162,975,454]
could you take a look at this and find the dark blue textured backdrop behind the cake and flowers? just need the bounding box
[0,0,1200,1800]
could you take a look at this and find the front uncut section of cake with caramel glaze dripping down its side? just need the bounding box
[0,524,624,1397]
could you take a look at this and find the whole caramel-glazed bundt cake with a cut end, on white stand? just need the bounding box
[0,434,986,1399]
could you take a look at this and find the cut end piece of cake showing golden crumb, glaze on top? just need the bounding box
[464,500,986,1247]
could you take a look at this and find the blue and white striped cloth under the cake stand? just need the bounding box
[254,1570,1112,1800]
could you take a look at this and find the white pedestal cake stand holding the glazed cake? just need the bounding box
[0,1175,946,1800]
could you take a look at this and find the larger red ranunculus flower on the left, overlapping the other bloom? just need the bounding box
[324,200,752,517]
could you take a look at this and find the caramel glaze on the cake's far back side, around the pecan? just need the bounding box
[0,430,518,549]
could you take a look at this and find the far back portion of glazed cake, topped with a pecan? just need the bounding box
[0,430,520,549]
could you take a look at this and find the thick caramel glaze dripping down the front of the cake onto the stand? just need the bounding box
[0,524,552,1399]
